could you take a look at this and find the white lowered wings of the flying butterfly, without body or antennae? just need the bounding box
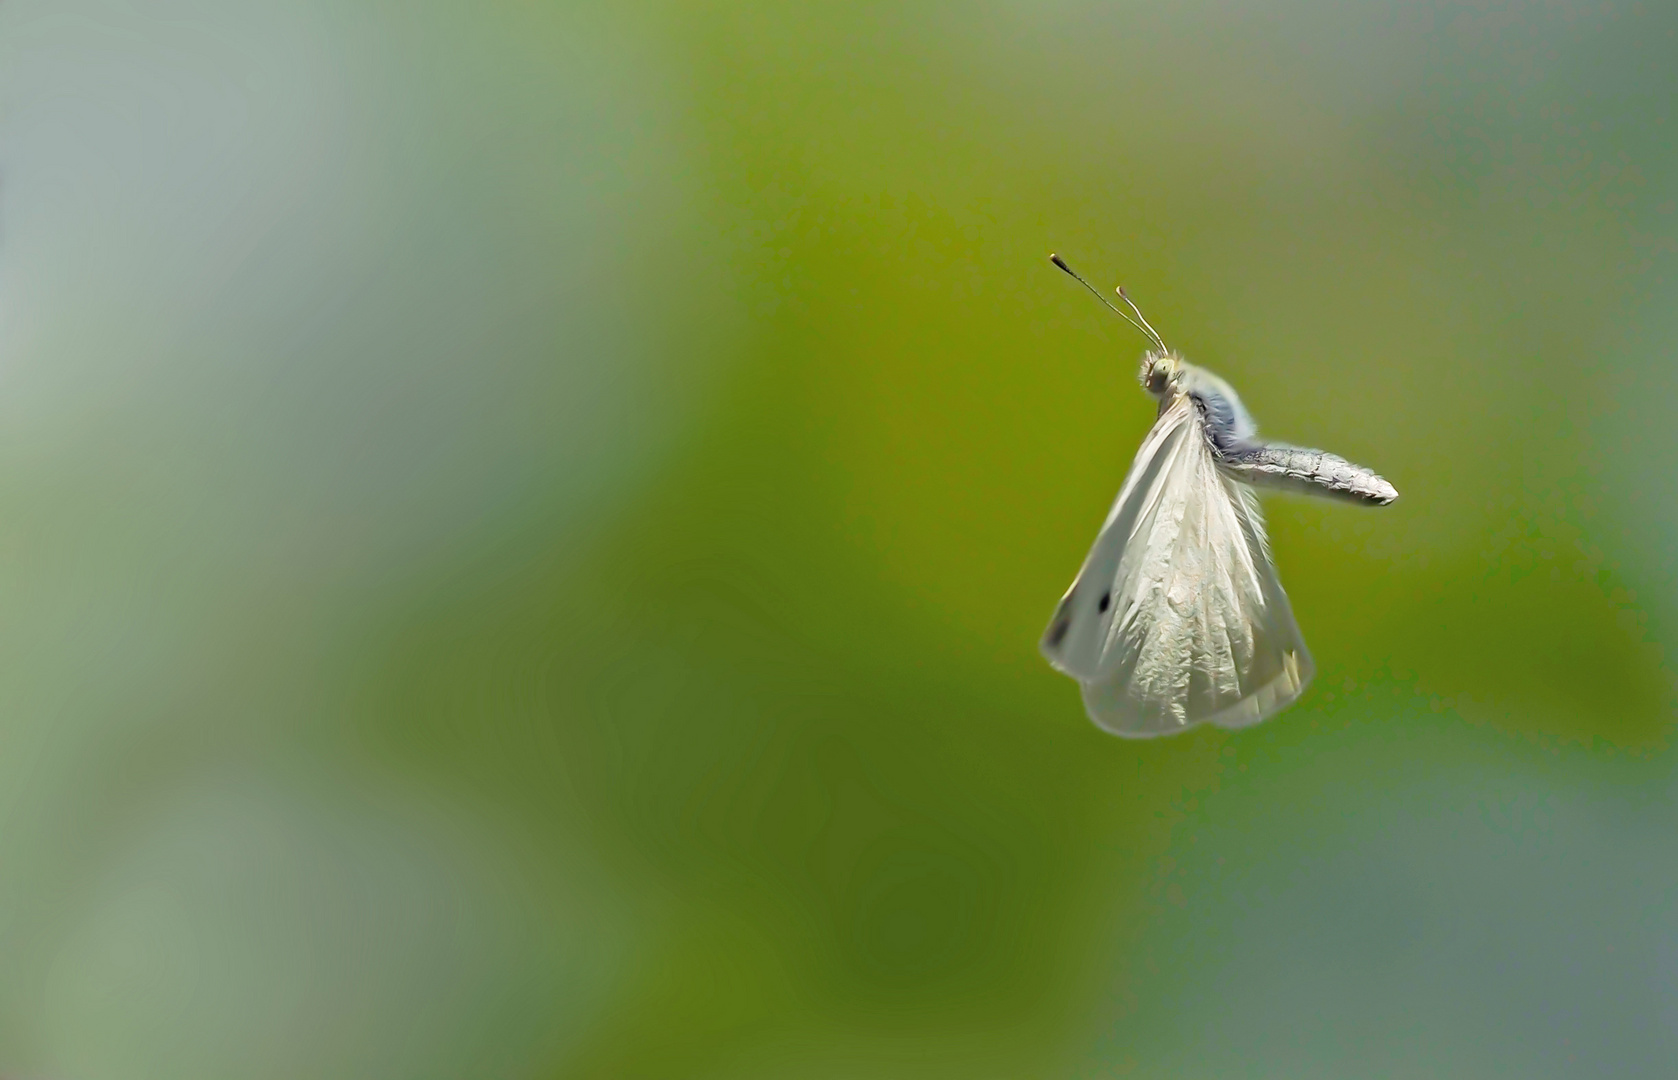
[1044,397,1312,736]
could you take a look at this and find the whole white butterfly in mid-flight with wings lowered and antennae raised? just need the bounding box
[1042,255,1398,738]
